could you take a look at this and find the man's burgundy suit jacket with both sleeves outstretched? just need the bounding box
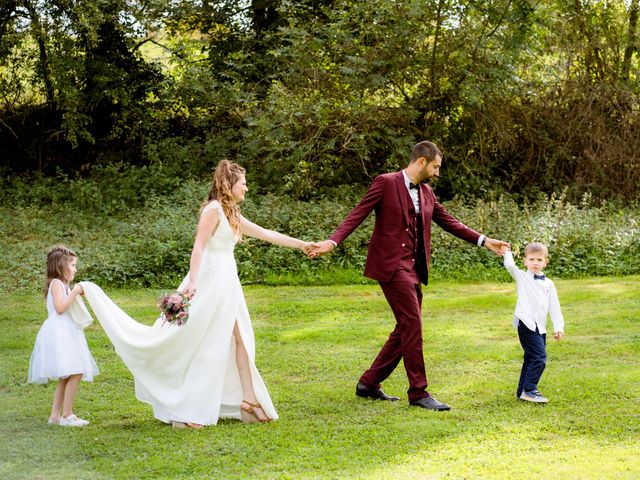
[329,171,480,282]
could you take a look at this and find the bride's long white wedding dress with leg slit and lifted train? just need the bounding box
[81,201,278,425]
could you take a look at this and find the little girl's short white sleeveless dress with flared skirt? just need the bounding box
[29,279,99,383]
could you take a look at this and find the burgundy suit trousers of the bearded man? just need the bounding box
[360,269,429,402]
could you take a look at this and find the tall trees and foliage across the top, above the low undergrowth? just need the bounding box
[0,0,640,203]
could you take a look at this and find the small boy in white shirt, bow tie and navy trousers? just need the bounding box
[504,242,564,403]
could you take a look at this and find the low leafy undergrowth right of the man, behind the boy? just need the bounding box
[432,191,640,278]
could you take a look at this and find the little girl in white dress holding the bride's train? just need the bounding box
[29,245,98,427]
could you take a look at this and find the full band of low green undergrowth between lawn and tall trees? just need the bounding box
[0,171,640,289]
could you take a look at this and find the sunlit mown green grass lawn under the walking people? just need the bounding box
[0,276,640,479]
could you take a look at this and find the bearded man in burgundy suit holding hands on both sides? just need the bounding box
[311,141,509,410]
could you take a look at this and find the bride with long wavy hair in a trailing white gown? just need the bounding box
[81,160,313,428]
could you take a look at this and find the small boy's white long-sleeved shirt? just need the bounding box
[504,251,564,334]
